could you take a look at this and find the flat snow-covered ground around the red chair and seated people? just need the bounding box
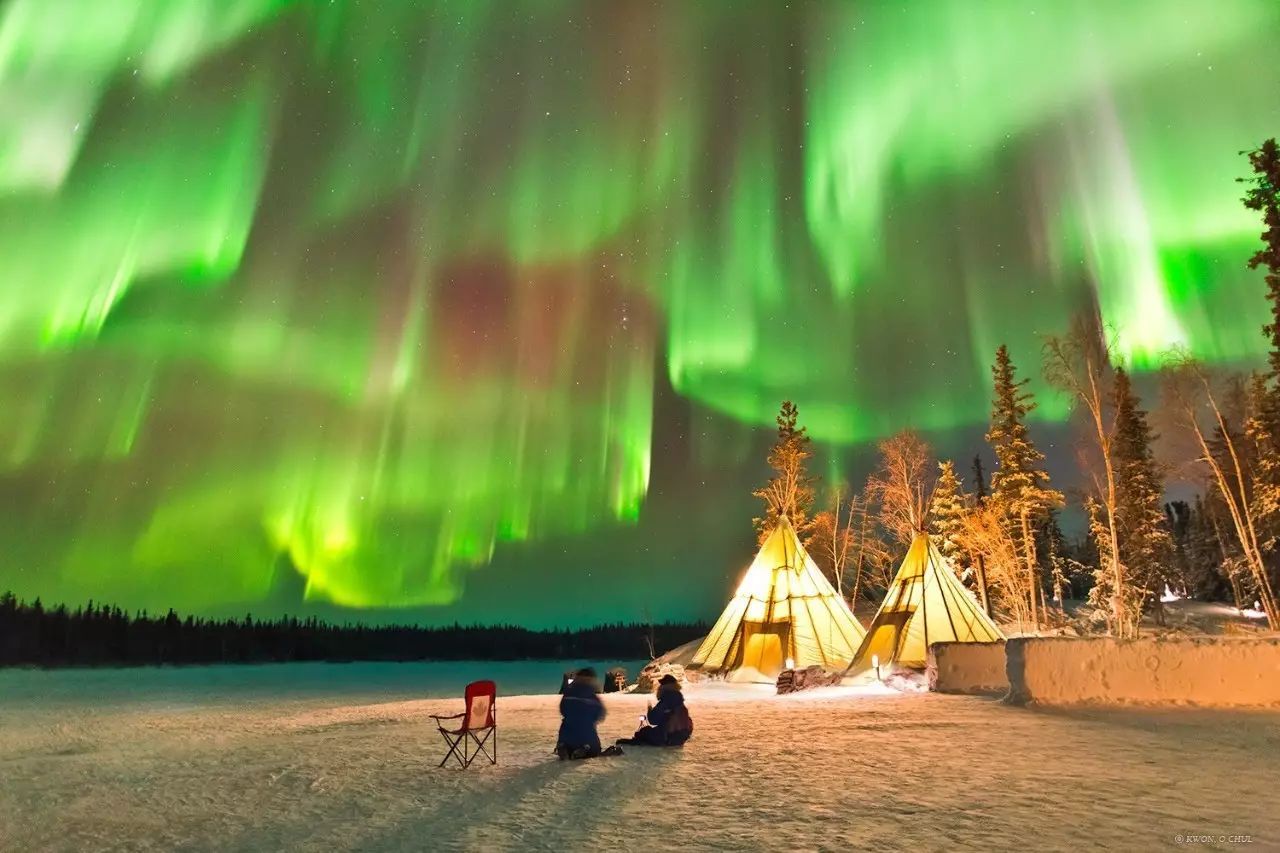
[0,662,1280,850]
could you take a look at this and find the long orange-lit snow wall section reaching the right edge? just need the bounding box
[1005,637,1280,708]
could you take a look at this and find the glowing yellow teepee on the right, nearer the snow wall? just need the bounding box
[846,533,1005,675]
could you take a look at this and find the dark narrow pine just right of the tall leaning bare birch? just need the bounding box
[1110,366,1172,635]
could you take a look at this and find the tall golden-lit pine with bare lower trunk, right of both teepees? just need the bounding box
[987,345,1062,624]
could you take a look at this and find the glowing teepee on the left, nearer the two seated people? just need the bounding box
[690,516,864,681]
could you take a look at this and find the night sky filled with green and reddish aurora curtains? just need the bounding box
[0,0,1280,620]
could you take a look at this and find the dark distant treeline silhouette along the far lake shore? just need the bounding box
[0,592,707,666]
